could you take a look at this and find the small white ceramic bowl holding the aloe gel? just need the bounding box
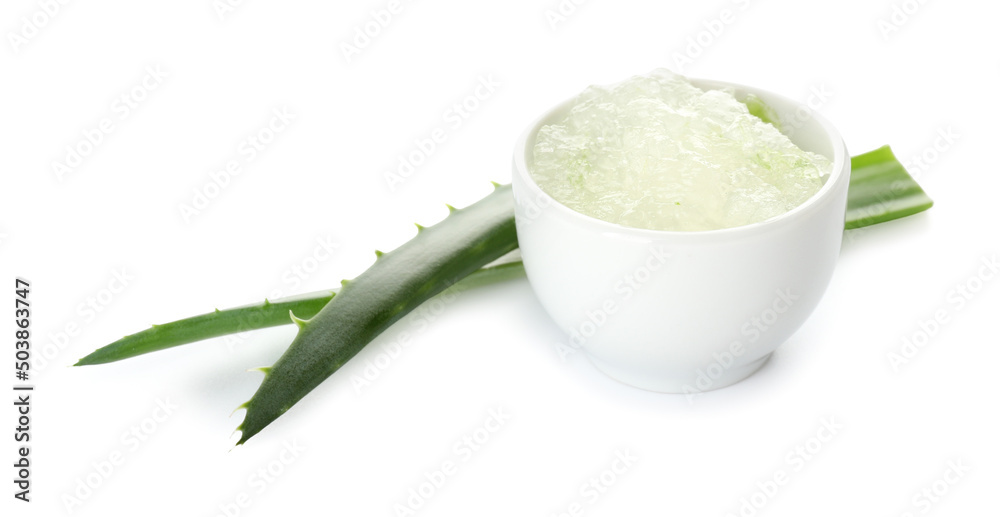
[513,76,851,393]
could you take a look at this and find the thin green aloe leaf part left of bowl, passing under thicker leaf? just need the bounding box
[74,260,524,366]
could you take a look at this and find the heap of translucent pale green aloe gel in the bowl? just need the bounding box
[530,69,832,231]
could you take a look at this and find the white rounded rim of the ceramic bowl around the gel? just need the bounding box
[514,74,851,239]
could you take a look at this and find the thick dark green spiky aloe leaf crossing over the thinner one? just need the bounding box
[237,185,517,444]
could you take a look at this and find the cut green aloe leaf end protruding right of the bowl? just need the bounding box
[845,145,934,229]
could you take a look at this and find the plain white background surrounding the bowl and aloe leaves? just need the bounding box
[0,0,1000,517]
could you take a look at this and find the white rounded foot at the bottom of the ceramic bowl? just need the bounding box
[586,354,771,394]
